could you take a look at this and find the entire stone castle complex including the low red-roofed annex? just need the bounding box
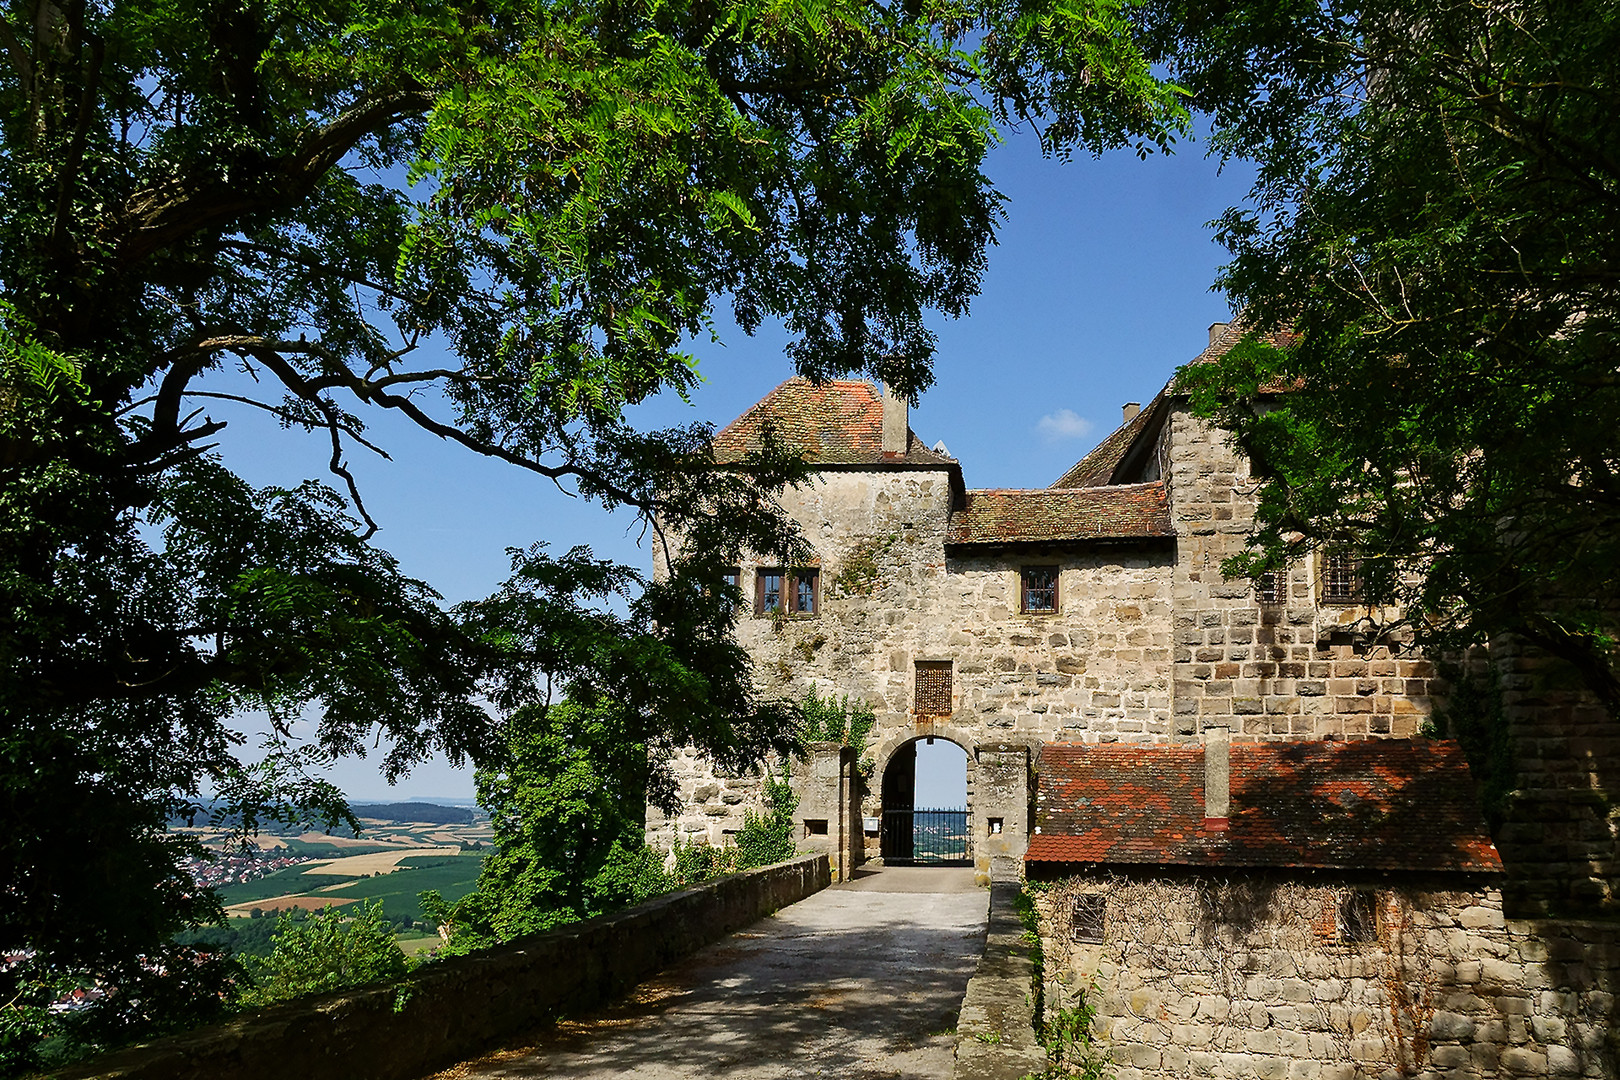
[648,324,1620,1080]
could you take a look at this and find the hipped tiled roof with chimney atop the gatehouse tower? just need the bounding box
[714,377,956,466]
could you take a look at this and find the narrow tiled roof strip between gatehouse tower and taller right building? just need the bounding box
[944,481,1175,544]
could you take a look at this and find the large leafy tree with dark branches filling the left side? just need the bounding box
[0,0,1183,1062]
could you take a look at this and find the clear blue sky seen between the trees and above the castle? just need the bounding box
[214,124,1251,800]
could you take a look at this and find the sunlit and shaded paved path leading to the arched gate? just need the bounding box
[437,866,988,1080]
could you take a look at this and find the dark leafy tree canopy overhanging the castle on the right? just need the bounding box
[1165,0,1620,709]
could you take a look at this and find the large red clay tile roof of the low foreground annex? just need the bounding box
[1024,738,1502,873]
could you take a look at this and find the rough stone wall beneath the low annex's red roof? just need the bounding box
[1037,876,1620,1080]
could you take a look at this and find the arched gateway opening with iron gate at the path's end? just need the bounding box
[880,738,972,866]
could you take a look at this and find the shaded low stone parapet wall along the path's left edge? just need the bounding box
[52,855,831,1080]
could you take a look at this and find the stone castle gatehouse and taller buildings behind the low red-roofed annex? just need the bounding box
[648,324,1434,878]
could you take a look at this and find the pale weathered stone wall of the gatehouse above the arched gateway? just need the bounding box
[648,470,1173,845]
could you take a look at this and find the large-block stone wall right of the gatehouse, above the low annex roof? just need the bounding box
[1166,408,1435,740]
